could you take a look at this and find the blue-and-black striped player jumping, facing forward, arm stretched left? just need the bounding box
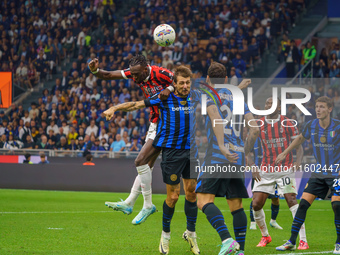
[103,66,205,254]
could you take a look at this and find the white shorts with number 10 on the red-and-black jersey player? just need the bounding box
[253,172,297,196]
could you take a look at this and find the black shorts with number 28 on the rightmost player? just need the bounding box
[303,174,340,199]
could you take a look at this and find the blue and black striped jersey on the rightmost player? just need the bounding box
[302,118,340,176]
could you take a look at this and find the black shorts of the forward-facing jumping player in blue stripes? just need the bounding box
[161,148,199,185]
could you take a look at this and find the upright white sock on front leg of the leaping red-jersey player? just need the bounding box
[137,164,152,208]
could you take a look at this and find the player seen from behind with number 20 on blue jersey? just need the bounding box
[196,62,259,255]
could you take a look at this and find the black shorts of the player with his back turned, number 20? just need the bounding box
[196,164,249,199]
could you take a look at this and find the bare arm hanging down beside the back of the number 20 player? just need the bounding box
[207,105,238,163]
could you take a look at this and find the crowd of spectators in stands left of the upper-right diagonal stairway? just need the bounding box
[0,0,316,155]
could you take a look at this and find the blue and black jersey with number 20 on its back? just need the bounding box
[204,89,250,165]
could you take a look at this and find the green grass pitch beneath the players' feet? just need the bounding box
[0,189,336,255]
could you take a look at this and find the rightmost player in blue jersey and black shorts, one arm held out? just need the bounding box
[276,96,340,254]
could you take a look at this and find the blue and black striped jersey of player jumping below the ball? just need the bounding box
[144,90,201,151]
